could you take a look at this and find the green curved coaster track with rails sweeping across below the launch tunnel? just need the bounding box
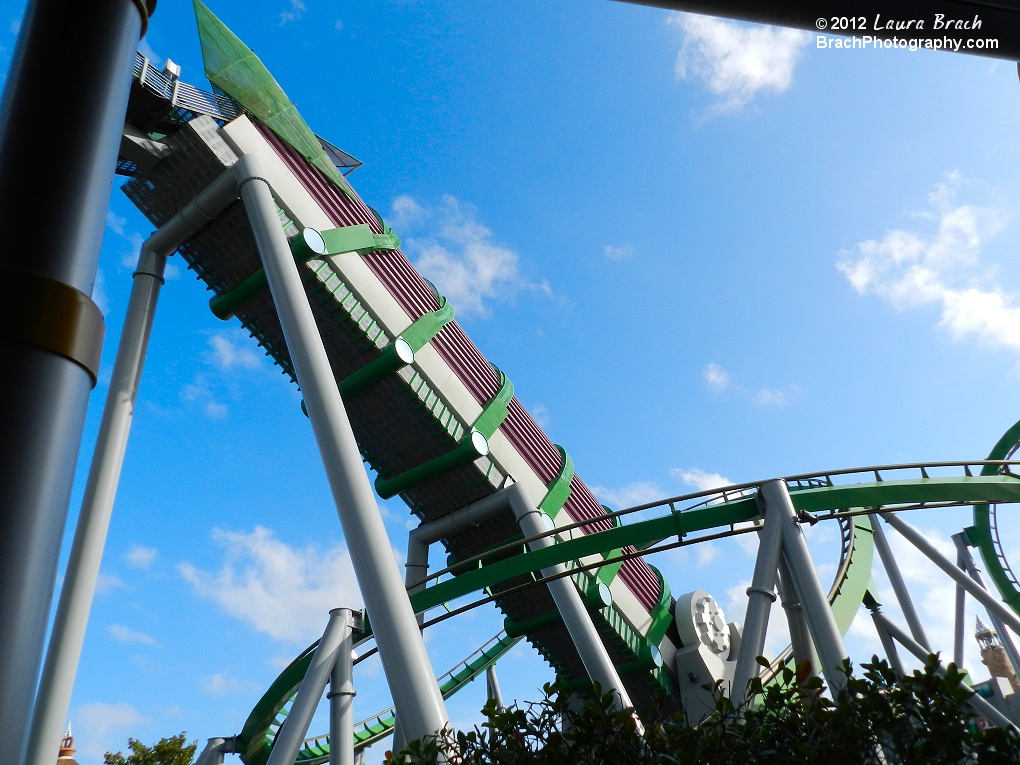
[239,460,1020,765]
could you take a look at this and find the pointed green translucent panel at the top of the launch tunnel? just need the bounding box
[194,0,352,194]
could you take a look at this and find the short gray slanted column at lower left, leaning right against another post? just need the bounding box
[266,608,350,765]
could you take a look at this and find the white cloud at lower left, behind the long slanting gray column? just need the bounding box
[177,526,361,643]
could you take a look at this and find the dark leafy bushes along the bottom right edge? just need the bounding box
[388,656,1020,765]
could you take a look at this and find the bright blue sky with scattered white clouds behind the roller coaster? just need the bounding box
[0,0,1020,765]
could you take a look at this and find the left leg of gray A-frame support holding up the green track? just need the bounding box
[729,499,782,707]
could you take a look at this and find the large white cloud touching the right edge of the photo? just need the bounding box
[836,171,1020,351]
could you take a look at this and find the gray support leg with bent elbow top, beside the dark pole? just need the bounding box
[27,171,237,765]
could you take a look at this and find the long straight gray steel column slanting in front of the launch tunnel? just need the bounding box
[239,162,450,742]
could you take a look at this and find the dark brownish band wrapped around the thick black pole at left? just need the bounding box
[0,268,106,388]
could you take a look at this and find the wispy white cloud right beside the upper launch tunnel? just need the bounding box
[395,195,552,316]
